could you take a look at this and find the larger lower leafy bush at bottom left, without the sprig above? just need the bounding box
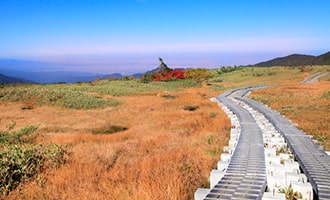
[0,144,65,195]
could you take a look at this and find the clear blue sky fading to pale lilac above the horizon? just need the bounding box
[0,0,330,69]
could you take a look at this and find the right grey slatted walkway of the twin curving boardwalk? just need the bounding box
[236,88,330,199]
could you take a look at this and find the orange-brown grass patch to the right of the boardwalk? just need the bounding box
[251,80,330,150]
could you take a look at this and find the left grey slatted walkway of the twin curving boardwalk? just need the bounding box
[201,88,266,199]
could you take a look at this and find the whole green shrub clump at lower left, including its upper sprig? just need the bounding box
[0,123,65,196]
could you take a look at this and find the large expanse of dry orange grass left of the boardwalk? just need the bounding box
[0,87,230,200]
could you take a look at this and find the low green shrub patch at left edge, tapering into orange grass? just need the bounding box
[0,84,120,109]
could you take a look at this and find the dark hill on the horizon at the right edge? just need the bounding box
[255,51,330,67]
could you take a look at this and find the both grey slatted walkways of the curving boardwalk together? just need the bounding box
[195,86,330,200]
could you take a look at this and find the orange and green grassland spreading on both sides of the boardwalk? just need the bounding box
[0,66,330,200]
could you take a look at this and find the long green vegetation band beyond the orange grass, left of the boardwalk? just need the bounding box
[0,80,201,109]
